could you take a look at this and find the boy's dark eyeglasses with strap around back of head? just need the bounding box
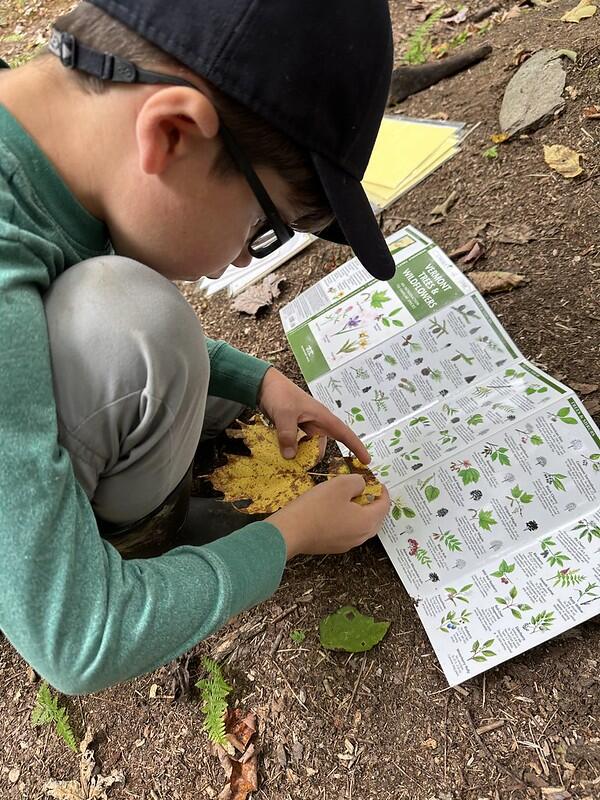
[48,29,294,258]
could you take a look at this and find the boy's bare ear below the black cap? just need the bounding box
[136,86,219,175]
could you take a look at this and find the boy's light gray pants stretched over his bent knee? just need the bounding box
[44,256,242,524]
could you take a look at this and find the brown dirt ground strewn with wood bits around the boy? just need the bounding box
[0,0,600,800]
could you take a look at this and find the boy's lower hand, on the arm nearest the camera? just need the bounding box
[267,475,390,559]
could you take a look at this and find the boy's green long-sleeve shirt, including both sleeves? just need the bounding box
[0,107,285,694]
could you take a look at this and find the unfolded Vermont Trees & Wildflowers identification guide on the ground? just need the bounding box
[281,227,600,684]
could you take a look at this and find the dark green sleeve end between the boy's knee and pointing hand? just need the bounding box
[206,339,271,408]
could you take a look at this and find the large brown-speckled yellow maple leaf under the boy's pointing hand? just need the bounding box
[206,418,322,514]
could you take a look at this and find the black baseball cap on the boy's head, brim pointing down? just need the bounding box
[90,0,395,280]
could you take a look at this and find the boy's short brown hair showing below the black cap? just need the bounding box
[54,1,333,231]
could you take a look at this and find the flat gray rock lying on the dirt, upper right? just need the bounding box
[500,49,567,136]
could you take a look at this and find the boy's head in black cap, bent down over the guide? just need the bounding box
[48,0,392,278]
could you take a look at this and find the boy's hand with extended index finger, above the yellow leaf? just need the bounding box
[258,367,371,462]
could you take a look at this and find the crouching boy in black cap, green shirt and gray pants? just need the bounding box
[0,0,393,694]
